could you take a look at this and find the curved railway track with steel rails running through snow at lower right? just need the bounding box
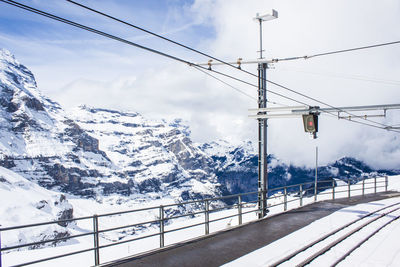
[269,202,400,266]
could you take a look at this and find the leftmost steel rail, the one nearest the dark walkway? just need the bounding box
[269,202,400,267]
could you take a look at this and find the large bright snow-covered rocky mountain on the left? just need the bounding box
[0,50,225,203]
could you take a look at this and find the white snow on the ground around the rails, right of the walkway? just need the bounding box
[223,176,400,267]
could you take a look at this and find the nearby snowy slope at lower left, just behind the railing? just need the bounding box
[0,167,73,251]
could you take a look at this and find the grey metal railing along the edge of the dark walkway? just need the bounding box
[0,176,388,267]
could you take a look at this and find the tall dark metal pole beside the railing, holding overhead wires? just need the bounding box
[255,10,278,218]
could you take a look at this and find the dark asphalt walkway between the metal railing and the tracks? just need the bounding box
[102,192,400,267]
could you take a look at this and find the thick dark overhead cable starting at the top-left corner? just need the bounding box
[0,0,397,132]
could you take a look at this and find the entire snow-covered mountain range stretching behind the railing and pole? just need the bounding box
[0,50,396,211]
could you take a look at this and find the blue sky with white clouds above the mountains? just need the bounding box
[0,0,400,167]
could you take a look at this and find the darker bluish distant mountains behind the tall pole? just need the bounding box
[202,141,400,199]
